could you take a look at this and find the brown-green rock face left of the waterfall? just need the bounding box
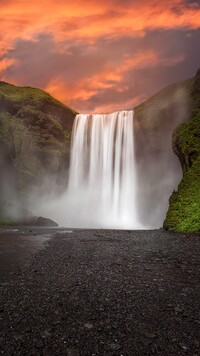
[0,82,76,221]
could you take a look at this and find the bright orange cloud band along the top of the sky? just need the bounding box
[0,0,200,53]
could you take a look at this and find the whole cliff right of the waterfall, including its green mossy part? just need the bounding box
[135,69,200,231]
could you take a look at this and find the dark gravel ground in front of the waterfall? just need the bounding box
[0,230,200,356]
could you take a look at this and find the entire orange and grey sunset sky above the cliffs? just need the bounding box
[0,0,200,112]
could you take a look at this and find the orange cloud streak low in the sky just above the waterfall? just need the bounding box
[45,51,166,112]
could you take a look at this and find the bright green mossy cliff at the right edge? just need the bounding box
[164,113,200,232]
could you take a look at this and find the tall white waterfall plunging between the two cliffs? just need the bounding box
[65,110,141,229]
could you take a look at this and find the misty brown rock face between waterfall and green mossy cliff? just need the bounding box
[135,79,194,227]
